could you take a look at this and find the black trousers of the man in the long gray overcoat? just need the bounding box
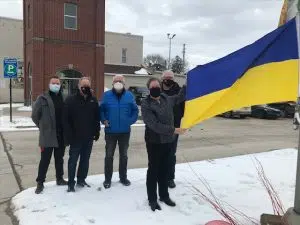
[36,138,65,183]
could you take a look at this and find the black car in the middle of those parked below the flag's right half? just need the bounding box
[252,105,284,119]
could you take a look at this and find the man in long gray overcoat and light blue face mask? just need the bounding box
[31,76,67,194]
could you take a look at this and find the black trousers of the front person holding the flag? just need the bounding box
[146,143,172,202]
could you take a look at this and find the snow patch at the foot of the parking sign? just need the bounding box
[0,116,37,132]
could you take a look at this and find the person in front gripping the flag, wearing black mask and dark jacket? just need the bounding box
[141,78,186,211]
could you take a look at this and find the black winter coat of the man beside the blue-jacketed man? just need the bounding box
[63,91,100,145]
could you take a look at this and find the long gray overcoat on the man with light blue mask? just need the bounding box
[31,92,58,148]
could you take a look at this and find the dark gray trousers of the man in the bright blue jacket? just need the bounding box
[104,133,130,181]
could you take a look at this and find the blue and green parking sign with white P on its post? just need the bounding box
[3,58,18,122]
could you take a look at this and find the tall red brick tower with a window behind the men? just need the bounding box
[23,0,105,104]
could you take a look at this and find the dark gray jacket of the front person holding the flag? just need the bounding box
[141,86,186,144]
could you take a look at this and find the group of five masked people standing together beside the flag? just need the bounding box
[32,71,186,211]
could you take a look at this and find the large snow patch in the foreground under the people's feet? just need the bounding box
[12,149,297,225]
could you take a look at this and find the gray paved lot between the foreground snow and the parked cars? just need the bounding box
[1,118,298,191]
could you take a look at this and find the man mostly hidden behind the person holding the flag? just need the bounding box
[162,71,184,188]
